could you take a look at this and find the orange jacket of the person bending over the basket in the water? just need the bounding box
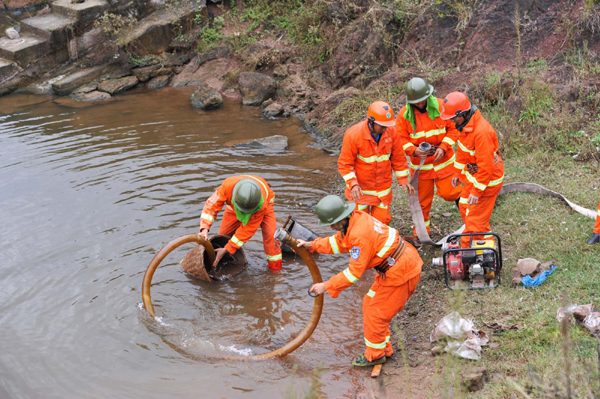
[200,175,275,254]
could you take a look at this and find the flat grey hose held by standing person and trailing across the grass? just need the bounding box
[408,159,597,246]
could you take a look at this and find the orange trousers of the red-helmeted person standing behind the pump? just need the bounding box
[458,190,500,248]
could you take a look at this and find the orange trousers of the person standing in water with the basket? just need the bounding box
[219,206,282,270]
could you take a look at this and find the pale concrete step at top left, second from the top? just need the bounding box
[21,13,76,47]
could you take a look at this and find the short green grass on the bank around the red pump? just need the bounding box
[391,152,600,398]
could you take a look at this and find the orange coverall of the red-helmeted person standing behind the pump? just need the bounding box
[454,110,504,248]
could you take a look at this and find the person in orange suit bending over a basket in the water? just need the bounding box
[200,175,281,270]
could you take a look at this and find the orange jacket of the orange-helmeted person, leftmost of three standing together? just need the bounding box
[338,120,408,205]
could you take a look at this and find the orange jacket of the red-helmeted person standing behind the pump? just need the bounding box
[454,110,504,198]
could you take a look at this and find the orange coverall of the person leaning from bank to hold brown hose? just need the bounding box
[311,211,423,361]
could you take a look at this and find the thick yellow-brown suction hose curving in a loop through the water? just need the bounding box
[142,229,324,360]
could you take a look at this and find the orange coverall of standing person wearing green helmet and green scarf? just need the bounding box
[396,98,461,236]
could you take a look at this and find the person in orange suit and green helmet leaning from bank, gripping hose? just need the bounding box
[298,195,423,367]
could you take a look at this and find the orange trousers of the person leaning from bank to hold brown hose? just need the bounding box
[363,274,421,361]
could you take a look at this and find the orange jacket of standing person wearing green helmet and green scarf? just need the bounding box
[396,98,458,180]
